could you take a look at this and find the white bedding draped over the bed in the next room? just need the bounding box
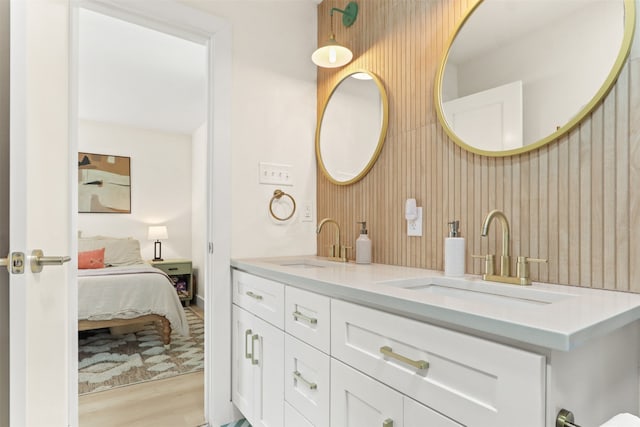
[78,264,189,336]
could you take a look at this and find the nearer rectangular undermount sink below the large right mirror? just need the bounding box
[378,277,575,307]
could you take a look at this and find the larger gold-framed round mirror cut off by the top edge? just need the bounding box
[435,0,635,156]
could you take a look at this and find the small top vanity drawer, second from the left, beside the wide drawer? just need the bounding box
[284,286,331,354]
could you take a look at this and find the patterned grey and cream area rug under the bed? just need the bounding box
[78,307,204,394]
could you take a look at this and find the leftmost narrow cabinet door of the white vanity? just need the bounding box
[231,305,255,418]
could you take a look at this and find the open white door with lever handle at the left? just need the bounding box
[9,0,75,426]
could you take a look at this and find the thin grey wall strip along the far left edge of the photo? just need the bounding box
[0,0,9,427]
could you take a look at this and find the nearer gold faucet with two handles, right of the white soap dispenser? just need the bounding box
[473,209,547,285]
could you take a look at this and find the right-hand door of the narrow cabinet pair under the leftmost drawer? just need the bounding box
[249,317,284,427]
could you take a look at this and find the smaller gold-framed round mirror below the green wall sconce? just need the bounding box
[316,70,389,185]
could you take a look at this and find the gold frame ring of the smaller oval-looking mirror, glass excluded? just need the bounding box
[316,69,389,185]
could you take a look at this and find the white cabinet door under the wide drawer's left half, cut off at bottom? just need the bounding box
[331,359,404,427]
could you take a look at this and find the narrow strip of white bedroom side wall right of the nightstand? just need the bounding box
[191,123,207,305]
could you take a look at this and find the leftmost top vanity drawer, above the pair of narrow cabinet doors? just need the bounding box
[233,270,284,329]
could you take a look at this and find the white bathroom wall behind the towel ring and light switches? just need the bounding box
[184,0,317,258]
